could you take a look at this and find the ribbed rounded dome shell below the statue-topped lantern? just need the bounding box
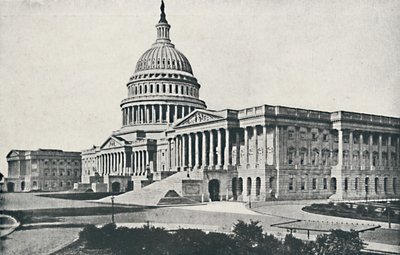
[135,43,193,74]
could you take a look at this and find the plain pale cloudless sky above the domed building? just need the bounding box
[0,0,400,174]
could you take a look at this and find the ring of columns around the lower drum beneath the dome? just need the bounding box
[122,104,195,126]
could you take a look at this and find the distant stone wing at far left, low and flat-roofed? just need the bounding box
[5,149,81,192]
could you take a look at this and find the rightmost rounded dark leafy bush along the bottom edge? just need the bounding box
[310,229,365,255]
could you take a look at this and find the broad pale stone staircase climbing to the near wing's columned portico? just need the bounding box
[99,172,193,206]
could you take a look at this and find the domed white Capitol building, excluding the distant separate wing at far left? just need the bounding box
[79,1,400,204]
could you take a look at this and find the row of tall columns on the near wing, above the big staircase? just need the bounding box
[164,126,267,170]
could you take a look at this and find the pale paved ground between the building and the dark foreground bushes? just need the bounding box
[2,193,400,254]
